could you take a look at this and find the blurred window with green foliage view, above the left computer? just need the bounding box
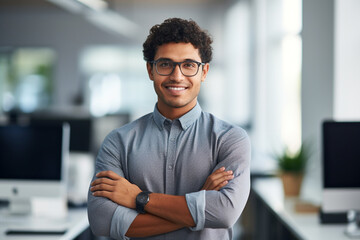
[0,47,55,112]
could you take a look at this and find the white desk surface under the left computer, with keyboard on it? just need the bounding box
[0,208,89,240]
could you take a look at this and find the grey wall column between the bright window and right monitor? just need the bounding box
[301,0,335,200]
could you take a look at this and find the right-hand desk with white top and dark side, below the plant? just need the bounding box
[252,178,350,240]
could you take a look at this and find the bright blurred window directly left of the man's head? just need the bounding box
[80,46,156,119]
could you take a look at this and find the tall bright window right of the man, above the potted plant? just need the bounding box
[252,0,302,157]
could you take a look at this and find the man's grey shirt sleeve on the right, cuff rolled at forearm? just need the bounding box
[187,128,251,230]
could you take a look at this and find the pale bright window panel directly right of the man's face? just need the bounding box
[199,1,252,127]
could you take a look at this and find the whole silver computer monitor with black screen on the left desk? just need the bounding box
[0,124,70,214]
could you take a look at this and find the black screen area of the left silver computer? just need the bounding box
[0,125,62,180]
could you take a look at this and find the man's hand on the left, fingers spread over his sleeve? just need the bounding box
[90,171,141,209]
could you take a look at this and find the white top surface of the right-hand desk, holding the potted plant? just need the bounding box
[252,178,350,240]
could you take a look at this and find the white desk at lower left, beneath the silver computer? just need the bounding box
[0,208,89,240]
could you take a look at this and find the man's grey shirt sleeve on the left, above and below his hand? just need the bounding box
[88,134,137,239]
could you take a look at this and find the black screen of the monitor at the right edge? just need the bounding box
[323,121,360,188]
